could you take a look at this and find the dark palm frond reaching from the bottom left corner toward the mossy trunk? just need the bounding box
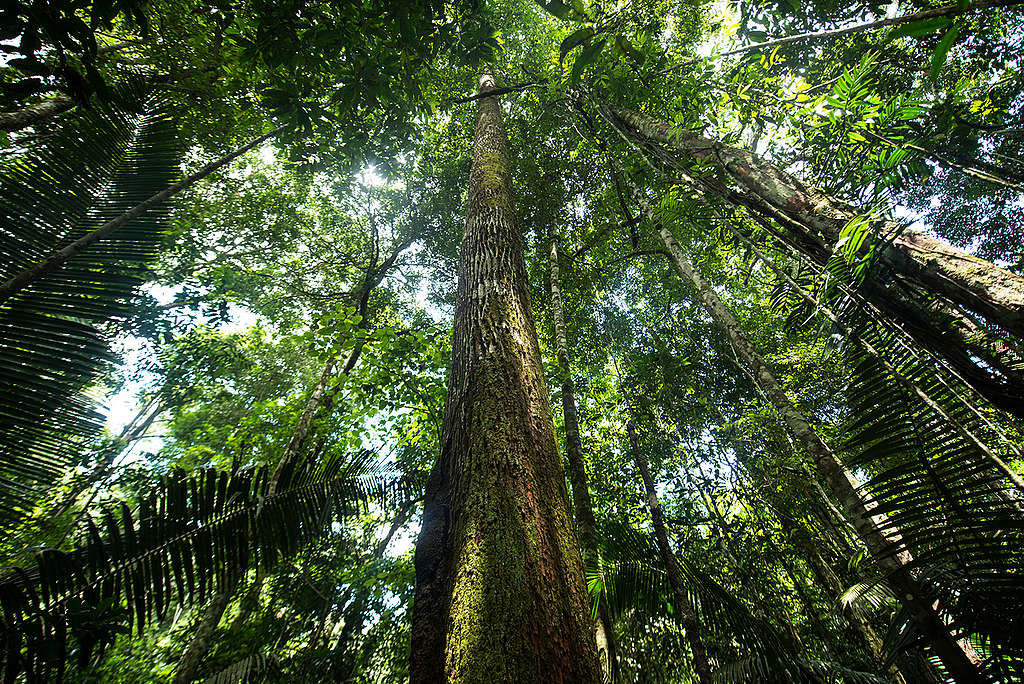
[0,452,402,679]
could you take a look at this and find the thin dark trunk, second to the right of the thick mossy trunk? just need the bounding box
[626,418,715,684]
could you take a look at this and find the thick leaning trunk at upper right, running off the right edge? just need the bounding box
[599,105,1024,416]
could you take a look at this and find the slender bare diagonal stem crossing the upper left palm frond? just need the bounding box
[0,126,286,304]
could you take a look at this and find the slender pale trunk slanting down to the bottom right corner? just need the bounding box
[634,197,985,684]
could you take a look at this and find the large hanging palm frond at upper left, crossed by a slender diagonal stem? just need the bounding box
[0,77,181,519]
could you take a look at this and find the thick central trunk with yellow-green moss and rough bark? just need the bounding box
[410,75,601,684]
